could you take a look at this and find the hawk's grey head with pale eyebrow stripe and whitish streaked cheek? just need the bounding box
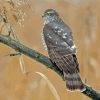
[42,9,59,24]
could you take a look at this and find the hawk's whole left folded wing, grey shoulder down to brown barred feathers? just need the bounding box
[43,25,79,73]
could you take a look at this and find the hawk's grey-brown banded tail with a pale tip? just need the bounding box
[64,73,85,91]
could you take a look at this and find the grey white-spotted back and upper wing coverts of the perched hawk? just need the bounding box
[43,22,76,54]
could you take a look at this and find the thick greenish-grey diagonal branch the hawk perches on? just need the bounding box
[0,35,100,100]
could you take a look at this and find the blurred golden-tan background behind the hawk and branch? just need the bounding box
[0,0,100,100]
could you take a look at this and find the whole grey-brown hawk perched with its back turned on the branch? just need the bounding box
[42,8,85,91]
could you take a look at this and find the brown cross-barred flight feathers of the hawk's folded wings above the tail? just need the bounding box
[48,50,79,74]
